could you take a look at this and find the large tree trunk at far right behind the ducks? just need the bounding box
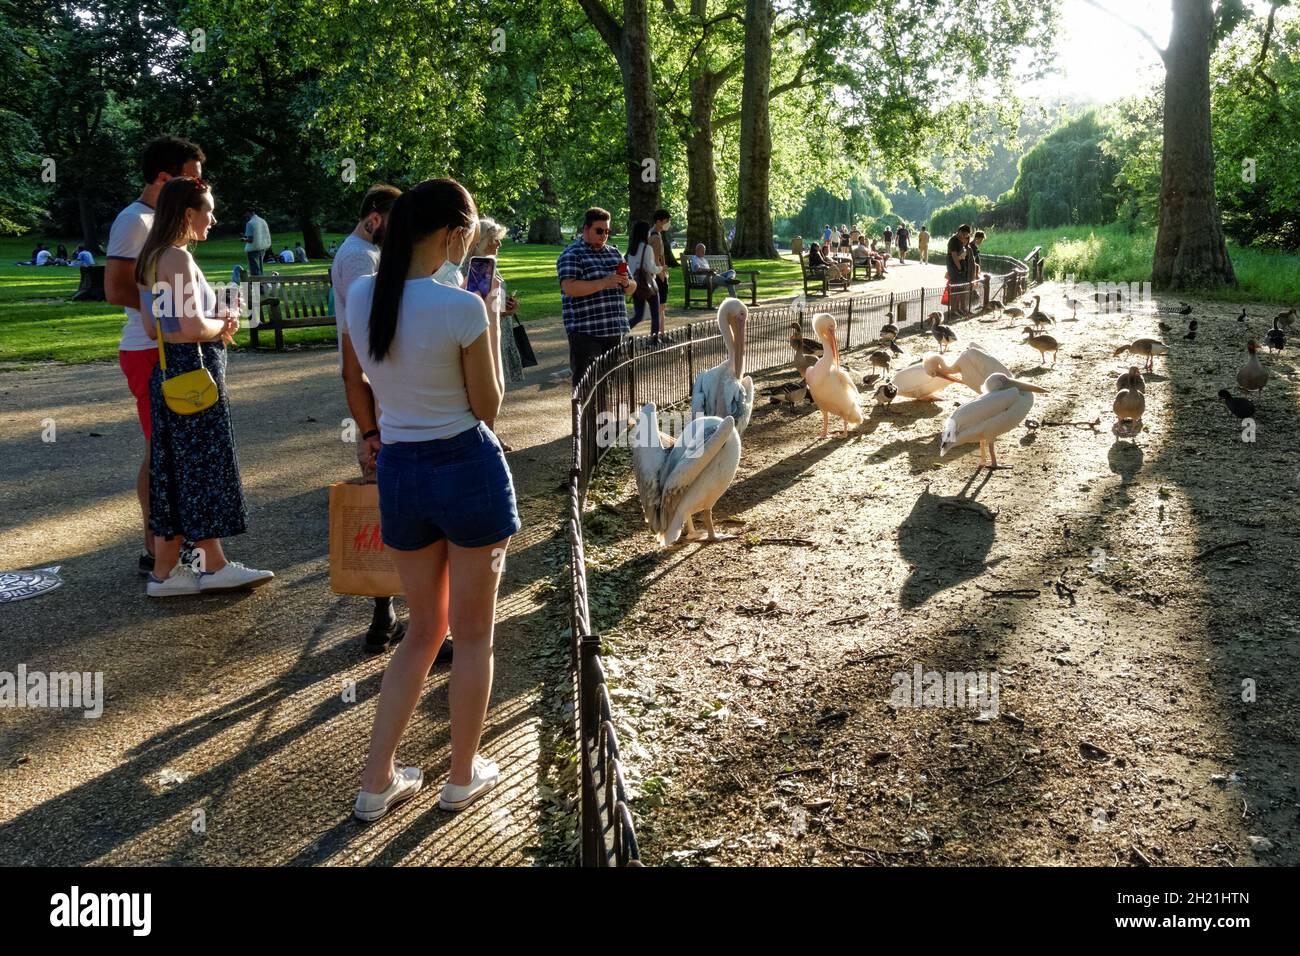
[1151,0,1236,289]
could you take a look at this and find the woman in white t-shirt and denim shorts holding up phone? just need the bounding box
[347,179,519,821]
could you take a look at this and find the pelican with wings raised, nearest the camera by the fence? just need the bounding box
[632,402,741,546]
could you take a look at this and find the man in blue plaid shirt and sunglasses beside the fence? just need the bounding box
[555,207,637,385]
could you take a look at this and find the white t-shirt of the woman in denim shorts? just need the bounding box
[347,276,488,445]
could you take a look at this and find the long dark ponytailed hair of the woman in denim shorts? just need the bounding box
[371,179,478,362]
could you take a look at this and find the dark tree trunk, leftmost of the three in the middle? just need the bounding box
[619,0,659,232]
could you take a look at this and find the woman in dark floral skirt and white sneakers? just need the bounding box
[135,176,276,598]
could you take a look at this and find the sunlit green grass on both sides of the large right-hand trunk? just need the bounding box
[980,224,1300,304]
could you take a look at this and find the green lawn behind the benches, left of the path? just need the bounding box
[0,234,800,369]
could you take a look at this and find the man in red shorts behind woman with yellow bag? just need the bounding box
[104,137,207,576]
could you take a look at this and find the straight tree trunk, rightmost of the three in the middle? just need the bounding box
[731,0,776,259]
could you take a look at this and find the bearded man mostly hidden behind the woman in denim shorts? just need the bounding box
[329,183,451,662]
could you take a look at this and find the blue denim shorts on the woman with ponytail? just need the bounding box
[377,421,519,551]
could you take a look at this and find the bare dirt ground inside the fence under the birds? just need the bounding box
[586,286,1300,865]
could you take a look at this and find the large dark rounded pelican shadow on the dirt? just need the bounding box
[898,468,998,607]
